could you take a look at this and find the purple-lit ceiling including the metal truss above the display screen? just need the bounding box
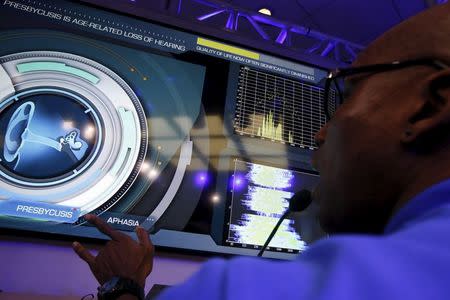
[84,0,449,65]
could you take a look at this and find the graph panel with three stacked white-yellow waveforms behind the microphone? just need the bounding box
[227,160,306,251]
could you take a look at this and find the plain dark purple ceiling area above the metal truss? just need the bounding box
[223,0,436,45]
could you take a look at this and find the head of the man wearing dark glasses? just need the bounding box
[314,4,450,233]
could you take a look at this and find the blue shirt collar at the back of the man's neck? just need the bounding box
[384,179,450,233]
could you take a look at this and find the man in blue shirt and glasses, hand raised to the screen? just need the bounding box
[74,4,450,300]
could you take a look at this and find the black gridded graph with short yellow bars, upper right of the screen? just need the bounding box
[234,66,335,149]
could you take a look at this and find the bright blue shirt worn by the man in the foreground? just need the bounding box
[159,180,450,300]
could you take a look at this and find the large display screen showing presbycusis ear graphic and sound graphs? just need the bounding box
[0,0,326,258]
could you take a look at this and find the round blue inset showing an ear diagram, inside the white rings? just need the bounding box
[0,88,102,186]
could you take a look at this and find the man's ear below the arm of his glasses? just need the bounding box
[401,69,450,147]
